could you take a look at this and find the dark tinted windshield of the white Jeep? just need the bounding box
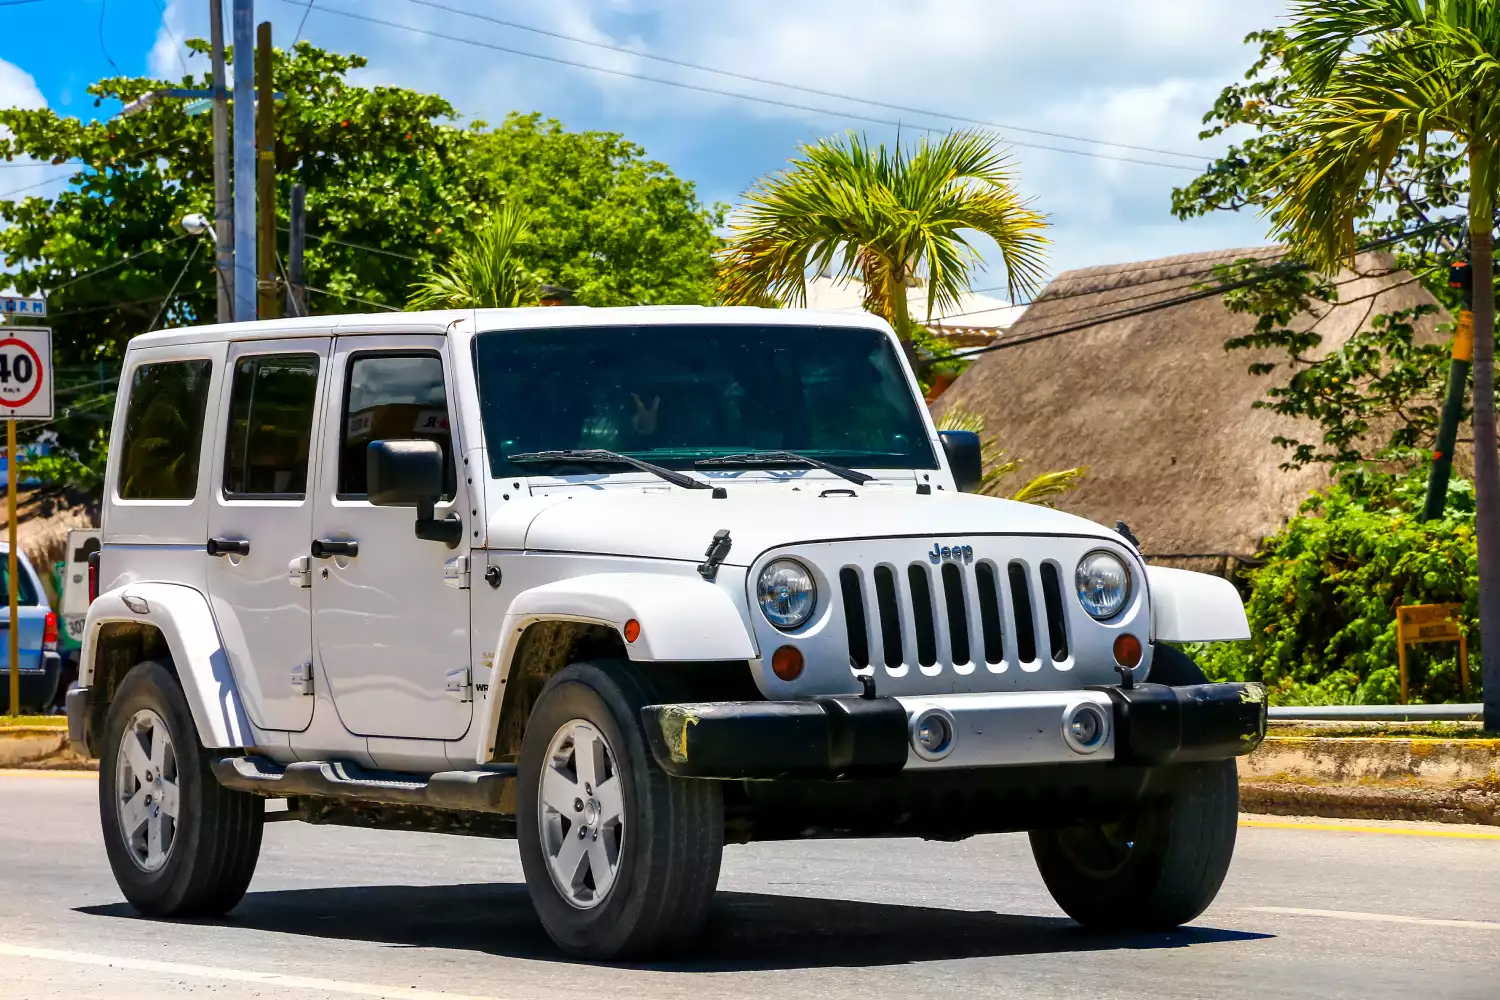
[474,325,938,475]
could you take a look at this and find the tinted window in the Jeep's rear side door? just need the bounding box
[224,354,318,499]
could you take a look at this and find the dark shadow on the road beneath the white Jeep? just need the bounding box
[80,883,1271,972]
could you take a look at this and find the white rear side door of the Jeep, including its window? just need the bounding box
[207,337,330,732]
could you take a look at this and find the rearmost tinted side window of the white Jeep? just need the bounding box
[120,360,213,499]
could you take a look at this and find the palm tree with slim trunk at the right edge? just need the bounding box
[1268,0,1500,729]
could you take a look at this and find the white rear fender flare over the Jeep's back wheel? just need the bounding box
[78,583,255,751]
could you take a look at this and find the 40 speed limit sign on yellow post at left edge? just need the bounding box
[0,325,53,715]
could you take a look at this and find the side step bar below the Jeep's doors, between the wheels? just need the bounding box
[213,757,516,813]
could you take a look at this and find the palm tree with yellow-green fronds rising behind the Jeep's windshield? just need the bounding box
[720,132,1047,351]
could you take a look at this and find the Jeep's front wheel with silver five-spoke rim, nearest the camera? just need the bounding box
[516,661,725,960]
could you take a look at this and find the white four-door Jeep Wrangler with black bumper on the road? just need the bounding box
[68,307,1266,960]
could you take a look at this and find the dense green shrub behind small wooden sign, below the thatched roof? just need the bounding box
[1191,468,1481,705]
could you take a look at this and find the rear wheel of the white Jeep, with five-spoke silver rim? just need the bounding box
[99,660,266,916]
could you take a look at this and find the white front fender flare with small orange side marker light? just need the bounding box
[477,573,759,763]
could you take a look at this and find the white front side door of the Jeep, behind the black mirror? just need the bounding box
[312,336,471,739]
